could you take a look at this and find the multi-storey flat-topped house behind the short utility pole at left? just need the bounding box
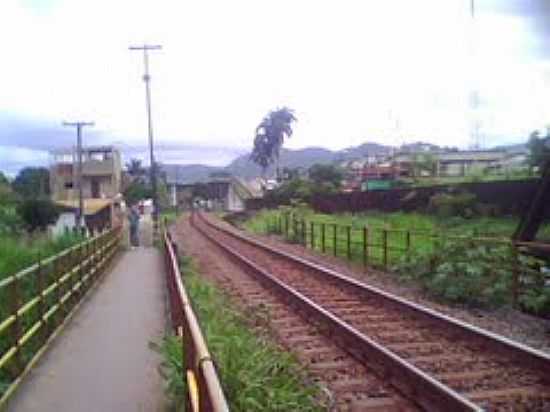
[50,146,122,231]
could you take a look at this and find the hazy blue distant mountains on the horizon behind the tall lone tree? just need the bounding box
[162,143,391,184]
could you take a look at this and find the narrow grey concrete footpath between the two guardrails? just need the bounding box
[8,247,165,412]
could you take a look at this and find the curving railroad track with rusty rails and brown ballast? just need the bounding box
[193,214,550,411]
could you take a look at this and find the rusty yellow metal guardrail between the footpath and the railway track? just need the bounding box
[162,229,229,412]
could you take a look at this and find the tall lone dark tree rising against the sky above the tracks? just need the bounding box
[250,107,296,179]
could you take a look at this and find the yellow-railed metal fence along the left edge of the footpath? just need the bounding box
[0,229,120,410]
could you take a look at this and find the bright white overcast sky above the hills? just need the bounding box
[0,0,550,171]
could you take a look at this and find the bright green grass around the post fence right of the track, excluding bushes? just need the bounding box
[243,208,532,267]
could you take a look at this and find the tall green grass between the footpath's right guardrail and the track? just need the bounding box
[158,258,322,412]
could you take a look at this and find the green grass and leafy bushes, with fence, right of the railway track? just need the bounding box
[244,208,550,315]
